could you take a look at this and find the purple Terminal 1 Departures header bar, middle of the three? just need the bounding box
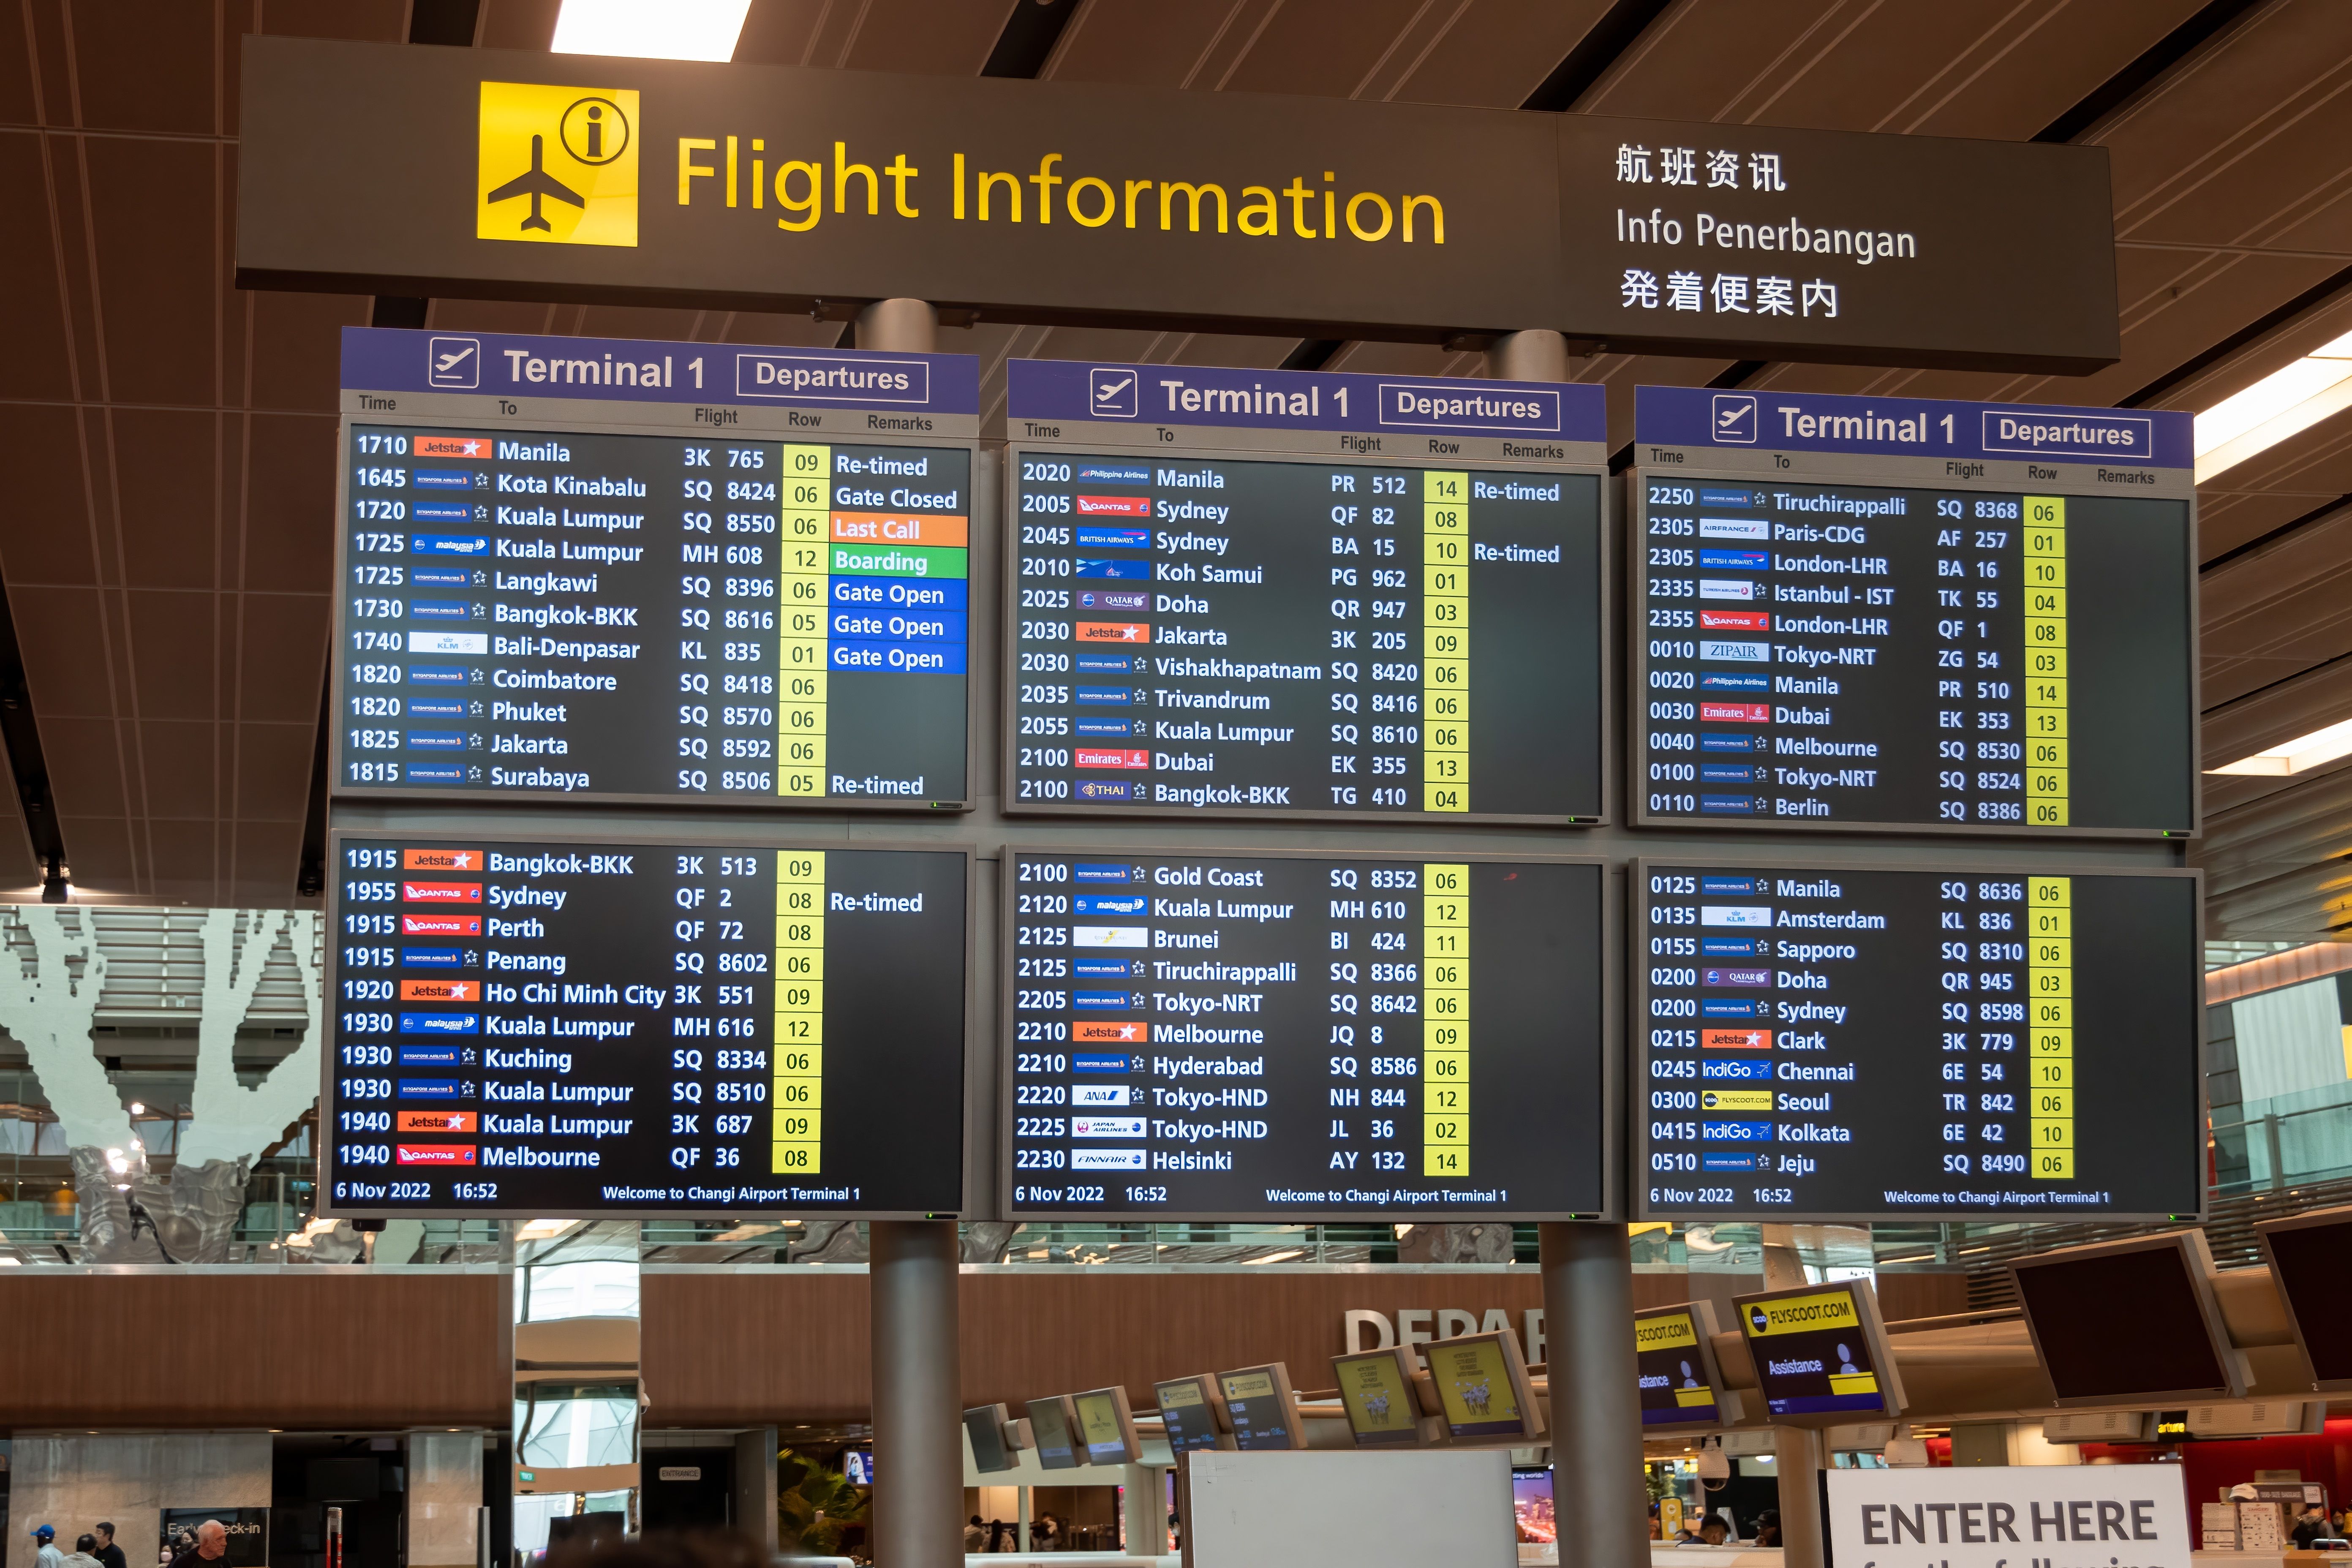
[1004,359,1609,442]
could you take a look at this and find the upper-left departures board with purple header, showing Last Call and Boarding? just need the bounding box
[334,329,976,808]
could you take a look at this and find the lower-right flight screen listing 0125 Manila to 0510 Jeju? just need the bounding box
[1632,858,2204,1222]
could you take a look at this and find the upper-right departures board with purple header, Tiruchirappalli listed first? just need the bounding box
[1628,386,2199,837]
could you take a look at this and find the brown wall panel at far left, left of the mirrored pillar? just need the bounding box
[0,1267,510,1432]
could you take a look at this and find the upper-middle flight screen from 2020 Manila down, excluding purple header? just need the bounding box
[1004,452,1602,820]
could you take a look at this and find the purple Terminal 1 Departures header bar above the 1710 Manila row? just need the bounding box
[343,327,981,414]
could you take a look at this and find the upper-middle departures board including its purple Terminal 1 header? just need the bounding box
[1004,359,1609,823]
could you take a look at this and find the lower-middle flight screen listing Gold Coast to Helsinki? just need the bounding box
[1002,849,1609,1220]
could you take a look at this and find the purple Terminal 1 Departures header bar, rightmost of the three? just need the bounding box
[1632,386,2197,468]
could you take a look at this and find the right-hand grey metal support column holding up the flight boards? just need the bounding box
[1519,1222,1646,1568]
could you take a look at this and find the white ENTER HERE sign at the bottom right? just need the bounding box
[1827,1465,2194,1568]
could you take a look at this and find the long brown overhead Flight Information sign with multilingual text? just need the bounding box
[237,38,2119,371]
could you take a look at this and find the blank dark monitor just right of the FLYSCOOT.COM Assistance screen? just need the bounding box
[2011,1234,2239,1406]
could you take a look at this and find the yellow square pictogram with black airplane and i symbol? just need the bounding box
[473,82,640,245]
